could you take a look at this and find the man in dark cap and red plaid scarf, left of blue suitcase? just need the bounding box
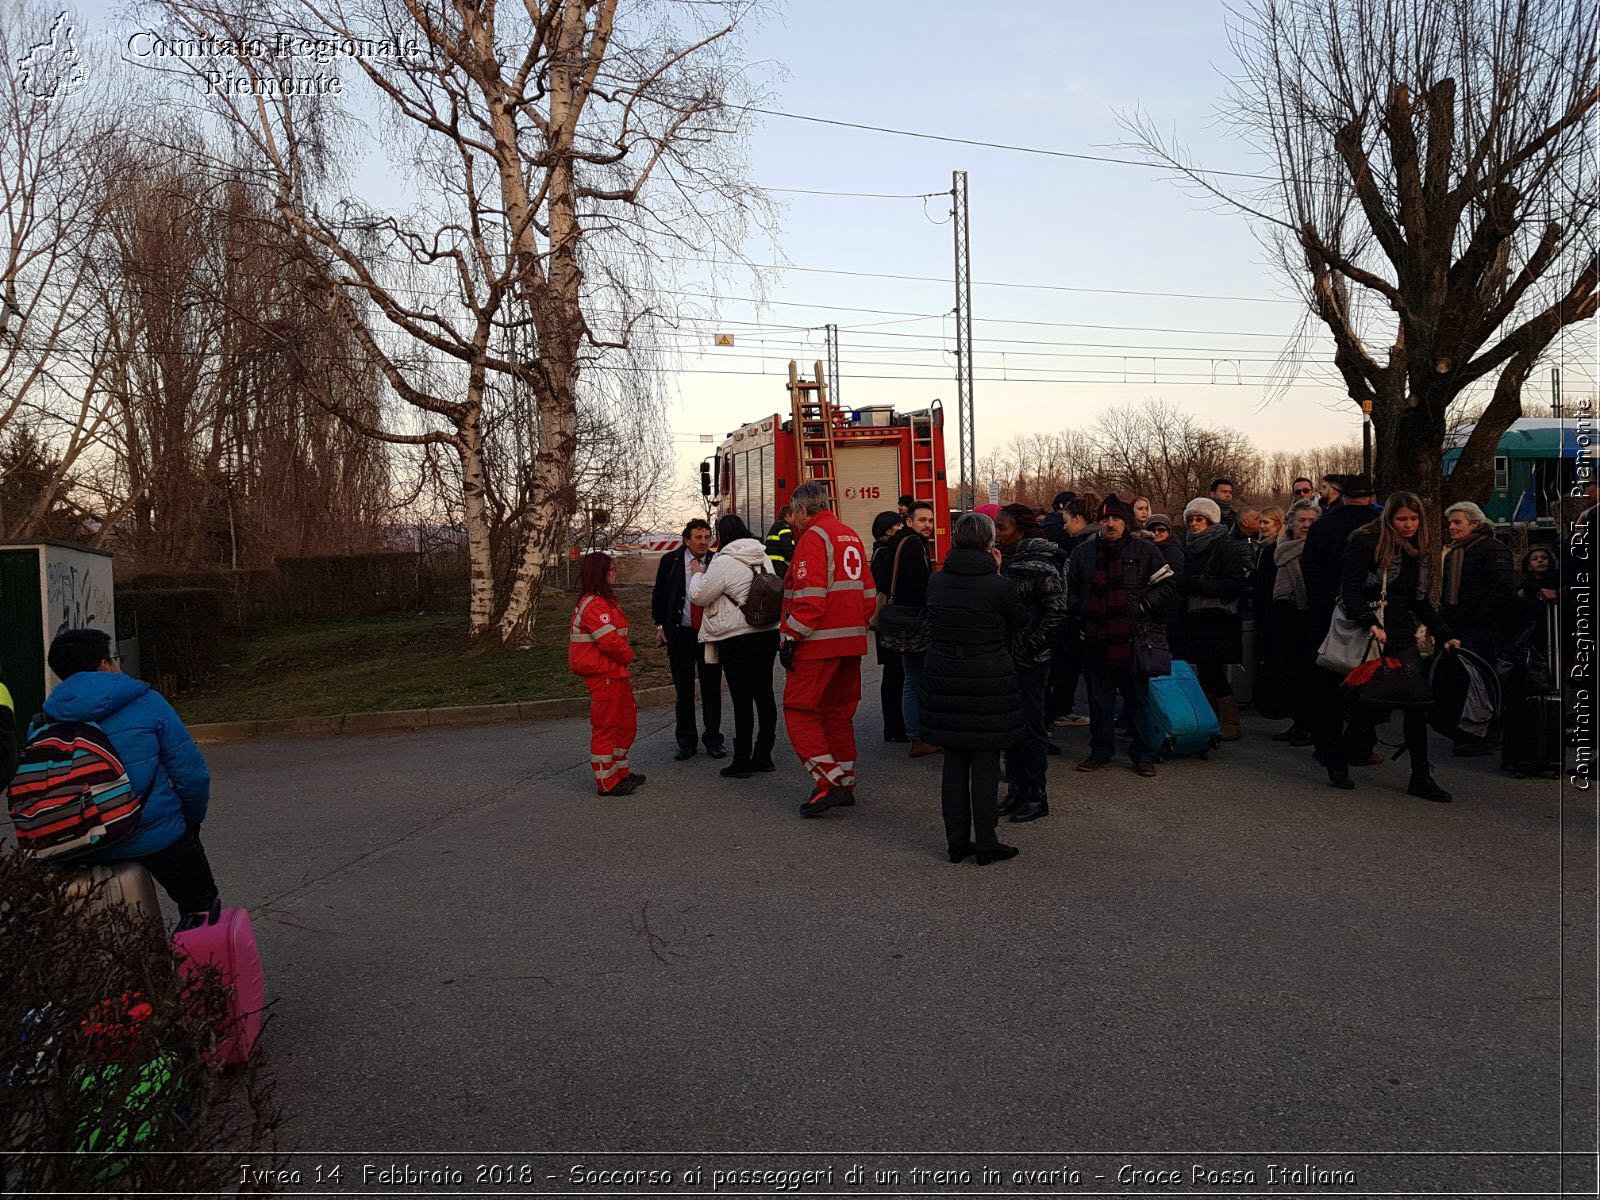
[1067,494,1173,778]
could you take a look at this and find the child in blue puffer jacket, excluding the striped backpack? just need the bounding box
[34,629,221,928]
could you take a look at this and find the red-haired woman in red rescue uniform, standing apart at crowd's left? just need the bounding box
[566,554,645,795]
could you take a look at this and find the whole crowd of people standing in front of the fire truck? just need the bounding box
[571,474,1558,864]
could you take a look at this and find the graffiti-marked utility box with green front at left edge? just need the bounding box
[0,541,117,730]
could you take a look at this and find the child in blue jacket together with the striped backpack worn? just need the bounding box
[6,629,221,925]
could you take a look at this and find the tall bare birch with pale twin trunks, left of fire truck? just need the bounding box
[155,0,768,648]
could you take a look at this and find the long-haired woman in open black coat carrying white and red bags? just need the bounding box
[1320,491,1461,803]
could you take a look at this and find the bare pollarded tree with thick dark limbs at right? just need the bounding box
[1130,0,1600,512]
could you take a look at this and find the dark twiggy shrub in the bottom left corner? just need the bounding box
[0,850,277,1195]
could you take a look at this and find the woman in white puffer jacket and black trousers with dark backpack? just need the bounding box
[690,515,778,779]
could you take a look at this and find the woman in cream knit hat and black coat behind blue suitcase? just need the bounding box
[1173,496,1250,742]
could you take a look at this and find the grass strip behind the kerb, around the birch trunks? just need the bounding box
[171,586,672,725]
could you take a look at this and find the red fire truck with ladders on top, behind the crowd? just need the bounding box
[701,363,950,562]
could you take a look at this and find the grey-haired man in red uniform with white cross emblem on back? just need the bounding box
[778,482,875,816]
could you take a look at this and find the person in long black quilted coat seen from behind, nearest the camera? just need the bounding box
[920,512,1027,866]
